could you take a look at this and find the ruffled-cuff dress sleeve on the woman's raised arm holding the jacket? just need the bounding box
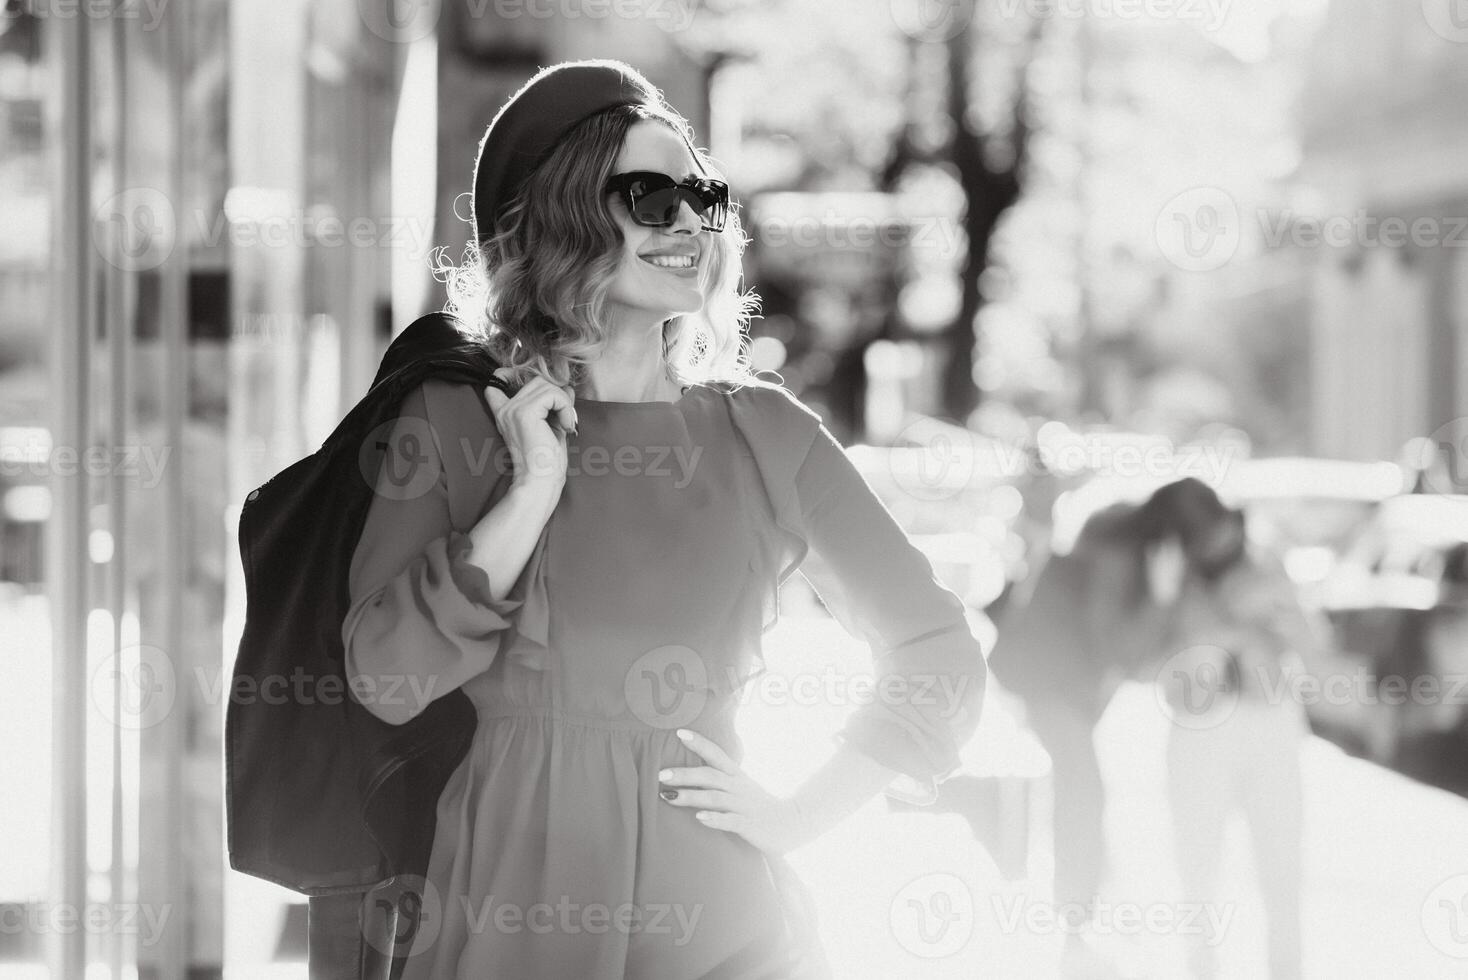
[342,386,524,725]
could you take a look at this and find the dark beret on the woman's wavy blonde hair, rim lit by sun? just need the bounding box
[473,60,664,244]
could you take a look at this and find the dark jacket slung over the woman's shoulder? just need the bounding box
[225,314,499,896]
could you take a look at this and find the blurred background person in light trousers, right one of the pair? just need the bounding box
[1158,484,1321,980]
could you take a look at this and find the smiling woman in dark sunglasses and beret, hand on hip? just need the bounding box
[342,62,985,980]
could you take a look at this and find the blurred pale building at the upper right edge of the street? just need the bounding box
[1299,0,1468,459]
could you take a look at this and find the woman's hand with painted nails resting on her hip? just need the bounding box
[659,729,824,854]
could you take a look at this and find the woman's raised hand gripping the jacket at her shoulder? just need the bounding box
[484,368,578,499]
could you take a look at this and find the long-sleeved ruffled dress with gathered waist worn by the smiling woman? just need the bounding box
[342,381,984,980]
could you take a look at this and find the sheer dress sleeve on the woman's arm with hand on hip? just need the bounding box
[796,413,988,804]
